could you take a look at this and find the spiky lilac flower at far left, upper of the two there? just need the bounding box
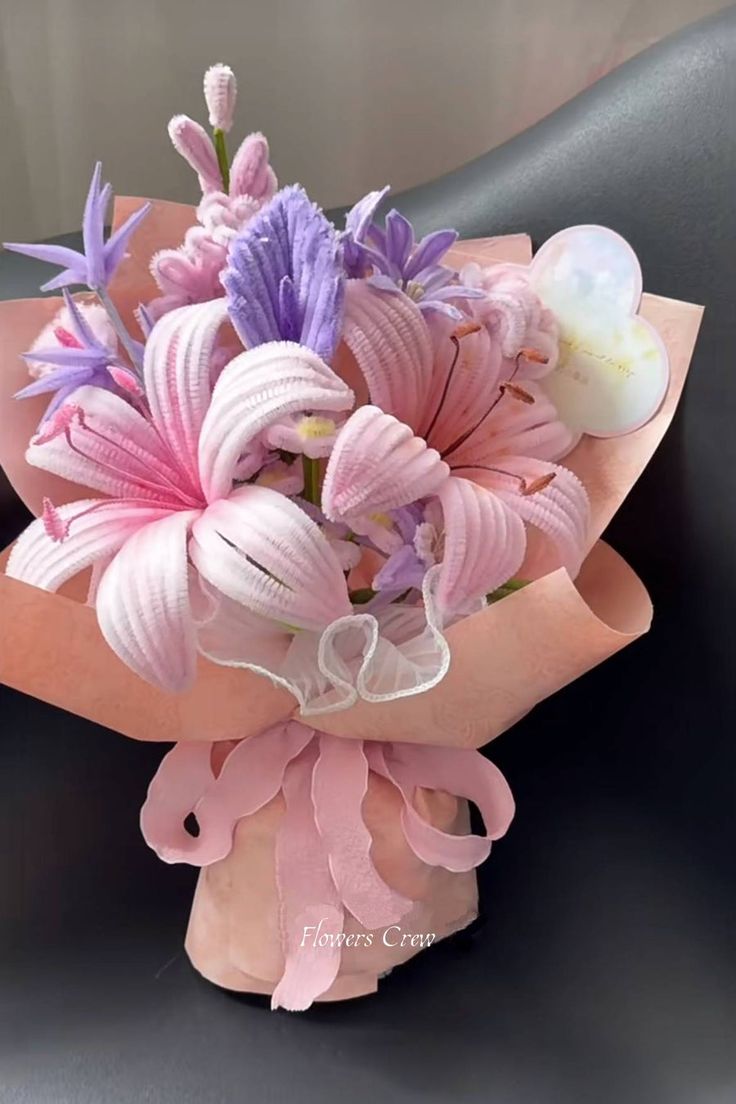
[4,161,151,291]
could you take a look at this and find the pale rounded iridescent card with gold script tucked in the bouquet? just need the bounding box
[530,226,670,437]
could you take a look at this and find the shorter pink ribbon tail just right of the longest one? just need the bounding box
[312,734,413,931]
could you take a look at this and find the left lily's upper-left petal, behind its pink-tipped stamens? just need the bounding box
[25,386,189,502]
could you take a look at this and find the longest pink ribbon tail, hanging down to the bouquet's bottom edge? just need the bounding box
[271,745,344,1011]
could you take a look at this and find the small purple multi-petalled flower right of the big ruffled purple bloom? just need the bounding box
[341,188,483,321]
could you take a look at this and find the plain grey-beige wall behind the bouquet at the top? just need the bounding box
[0,0,724,241]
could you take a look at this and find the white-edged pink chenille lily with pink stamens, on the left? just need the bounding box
[8,300,354,691]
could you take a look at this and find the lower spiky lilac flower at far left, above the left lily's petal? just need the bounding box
[15,288,127,423]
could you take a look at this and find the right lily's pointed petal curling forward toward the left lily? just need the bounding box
[322,406,449,521]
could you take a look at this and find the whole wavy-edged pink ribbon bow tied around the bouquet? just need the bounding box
[140,721,514,1011]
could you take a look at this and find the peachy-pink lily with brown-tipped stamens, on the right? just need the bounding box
[322,280,588,624]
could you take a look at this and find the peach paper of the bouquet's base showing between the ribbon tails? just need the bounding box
[185,775,478,1001]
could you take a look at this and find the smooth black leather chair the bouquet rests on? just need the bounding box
[0,8,736,1104]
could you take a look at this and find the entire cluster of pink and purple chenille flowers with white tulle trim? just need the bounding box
[8,66,588,713]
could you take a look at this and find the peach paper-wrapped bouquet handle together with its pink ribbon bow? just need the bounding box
[141,721,513,1010]
